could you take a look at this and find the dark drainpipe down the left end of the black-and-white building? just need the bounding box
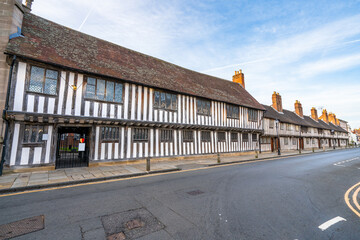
[0,55,16,176]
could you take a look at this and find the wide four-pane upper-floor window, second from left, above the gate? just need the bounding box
[85,77,123,103]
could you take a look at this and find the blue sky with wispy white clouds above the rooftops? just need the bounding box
[28,0,360,129]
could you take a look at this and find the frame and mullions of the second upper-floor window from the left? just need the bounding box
[84,76,125,104]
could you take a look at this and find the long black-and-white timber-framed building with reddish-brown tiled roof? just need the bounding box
[0,1,265,168]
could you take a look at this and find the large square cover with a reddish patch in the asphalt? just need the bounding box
[101,208,165,239]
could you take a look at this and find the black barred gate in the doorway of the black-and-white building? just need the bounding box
[55,128,89,169]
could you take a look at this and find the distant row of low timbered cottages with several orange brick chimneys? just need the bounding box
[261,92,349,151]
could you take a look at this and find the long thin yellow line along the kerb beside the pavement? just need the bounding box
[0,155,340,198]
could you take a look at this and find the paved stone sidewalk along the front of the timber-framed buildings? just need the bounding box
[0,146,352,194]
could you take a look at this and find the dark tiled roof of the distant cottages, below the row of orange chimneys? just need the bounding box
[263,105,347,132]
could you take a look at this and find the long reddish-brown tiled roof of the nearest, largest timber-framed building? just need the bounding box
[6,13,264,110]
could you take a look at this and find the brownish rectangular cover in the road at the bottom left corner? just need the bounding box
[0,215,45,240]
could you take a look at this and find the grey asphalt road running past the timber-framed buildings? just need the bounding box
[0,149,360,240]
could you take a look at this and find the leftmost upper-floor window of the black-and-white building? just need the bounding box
[28,66,58,95]
